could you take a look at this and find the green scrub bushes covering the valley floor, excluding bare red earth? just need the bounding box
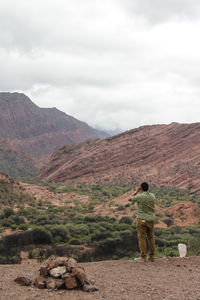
[0,177,200,263]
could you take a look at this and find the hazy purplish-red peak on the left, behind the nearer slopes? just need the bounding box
[0,93,108,165]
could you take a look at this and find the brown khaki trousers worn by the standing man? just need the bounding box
[136,219,155,258]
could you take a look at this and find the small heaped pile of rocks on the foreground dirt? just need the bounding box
[15,256,99,292]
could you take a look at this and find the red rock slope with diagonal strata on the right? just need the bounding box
[40,123,200,192]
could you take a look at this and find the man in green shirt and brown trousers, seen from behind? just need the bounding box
[128,182,155,262]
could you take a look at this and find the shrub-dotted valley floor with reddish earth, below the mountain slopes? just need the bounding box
[0,175,200,263]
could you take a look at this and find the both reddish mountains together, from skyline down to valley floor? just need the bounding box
[0,93,200,193]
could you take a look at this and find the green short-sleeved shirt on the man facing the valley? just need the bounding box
[131,192,155,221]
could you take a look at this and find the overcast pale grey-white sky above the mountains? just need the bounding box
[0,0,200,130]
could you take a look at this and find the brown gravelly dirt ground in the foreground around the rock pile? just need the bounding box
[0,257,200,300]
